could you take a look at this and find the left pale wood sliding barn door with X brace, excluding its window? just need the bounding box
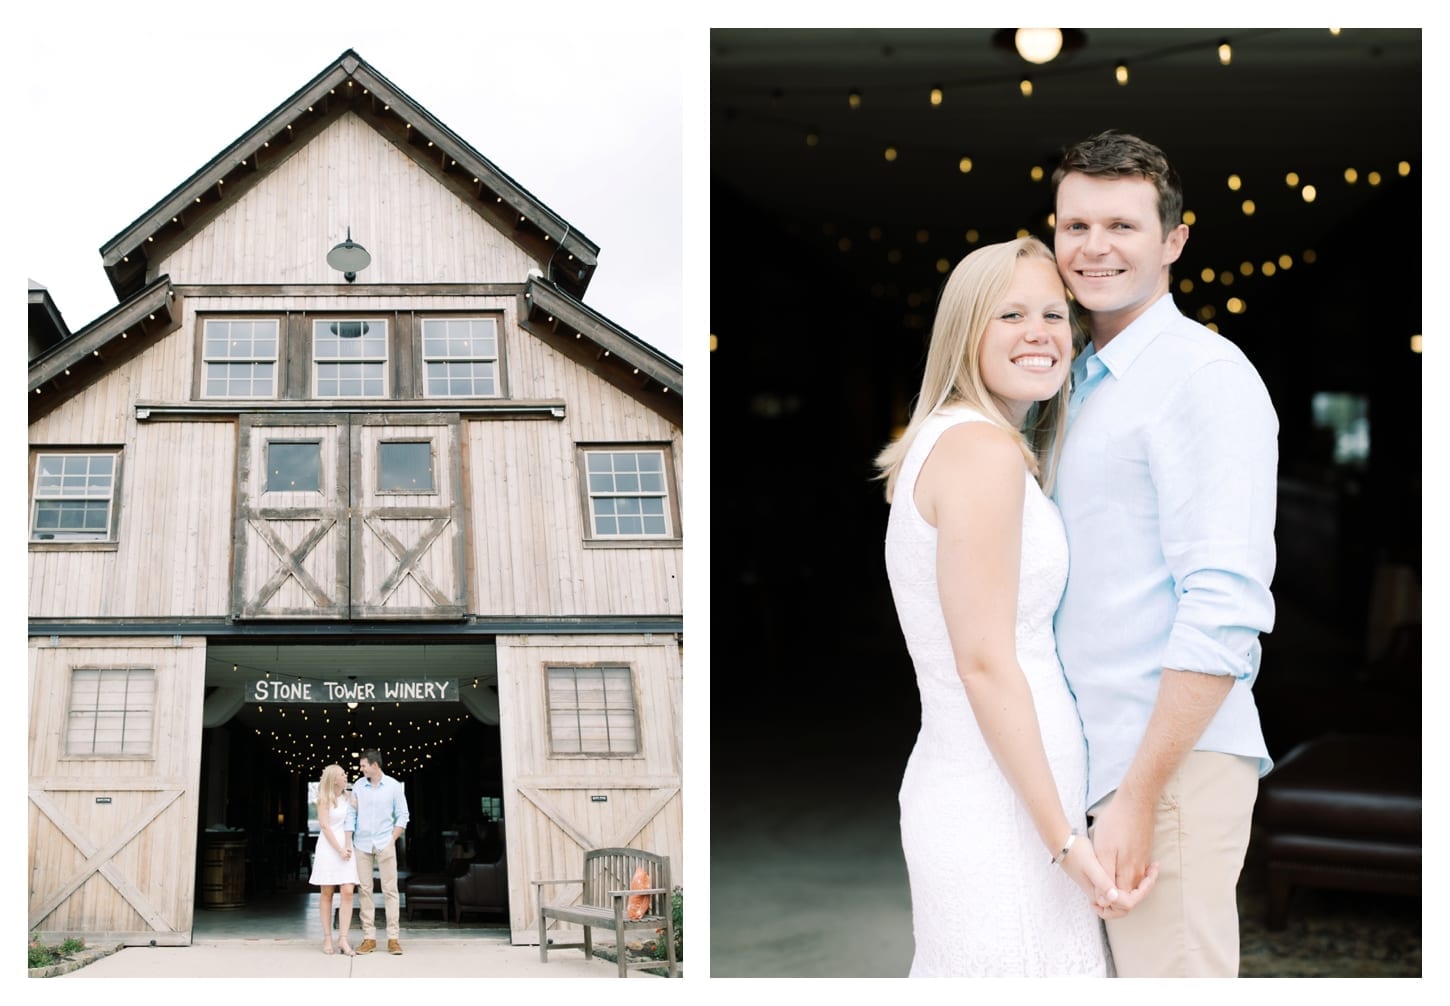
[26,638,206,945]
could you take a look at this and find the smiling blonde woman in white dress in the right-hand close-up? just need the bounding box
[877,238,1156,977]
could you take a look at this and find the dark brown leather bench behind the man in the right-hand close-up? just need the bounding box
[1256,732,1421,929]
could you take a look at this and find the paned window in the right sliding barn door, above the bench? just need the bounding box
[544,664,641,758]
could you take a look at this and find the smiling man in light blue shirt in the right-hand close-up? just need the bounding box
[1053,132,1279,977]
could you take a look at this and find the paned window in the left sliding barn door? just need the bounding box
[65,667,157,758]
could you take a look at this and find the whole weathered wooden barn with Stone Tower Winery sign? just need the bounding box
[28,49,684,945]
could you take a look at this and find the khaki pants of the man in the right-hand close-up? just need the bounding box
[1088,751,1259,978]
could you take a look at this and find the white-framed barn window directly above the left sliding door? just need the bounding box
[30,451,120,542]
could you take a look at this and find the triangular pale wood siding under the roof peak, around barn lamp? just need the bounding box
[148,112,537,284]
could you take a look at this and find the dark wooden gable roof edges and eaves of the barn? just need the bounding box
[29,49,684,419]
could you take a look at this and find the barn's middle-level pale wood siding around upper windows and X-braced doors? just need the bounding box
[29,289,687,618]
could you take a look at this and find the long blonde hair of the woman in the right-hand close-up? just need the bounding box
[876,238,1079,503]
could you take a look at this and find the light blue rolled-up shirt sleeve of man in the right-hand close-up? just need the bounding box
[1147,359,1279,678]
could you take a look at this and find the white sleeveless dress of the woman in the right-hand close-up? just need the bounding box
[886,406,1111,977]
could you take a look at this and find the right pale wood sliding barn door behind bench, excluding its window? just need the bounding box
[497,636,684,942]
